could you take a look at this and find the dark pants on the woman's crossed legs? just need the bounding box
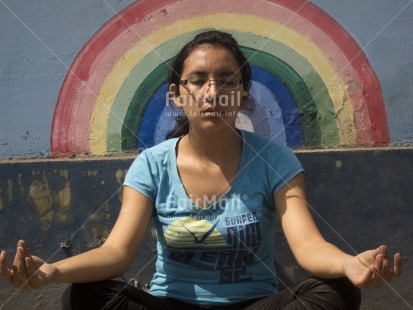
[62,278,361,310]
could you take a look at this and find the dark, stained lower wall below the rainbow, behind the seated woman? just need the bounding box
[0,148,413,310]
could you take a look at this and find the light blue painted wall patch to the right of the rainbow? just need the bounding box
[311,0,413,146]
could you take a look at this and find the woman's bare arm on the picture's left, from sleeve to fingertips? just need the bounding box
[0,186,153,289]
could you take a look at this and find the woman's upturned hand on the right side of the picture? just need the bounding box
[344,245,402,288]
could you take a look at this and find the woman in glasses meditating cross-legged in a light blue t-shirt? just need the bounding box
[0,31,401,309]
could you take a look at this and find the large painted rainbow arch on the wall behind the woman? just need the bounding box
[51,0,389,156]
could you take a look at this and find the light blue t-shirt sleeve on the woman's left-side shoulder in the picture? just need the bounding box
[123,150,159,203]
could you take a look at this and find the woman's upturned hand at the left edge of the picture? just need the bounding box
[0,240,57,290]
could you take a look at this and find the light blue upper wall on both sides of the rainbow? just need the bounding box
[0,0,413,158]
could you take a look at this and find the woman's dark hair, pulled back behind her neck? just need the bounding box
[166,30,251,139]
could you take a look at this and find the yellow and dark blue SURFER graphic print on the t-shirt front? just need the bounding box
[163,212,262,284]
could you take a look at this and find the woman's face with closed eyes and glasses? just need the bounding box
[170,45,245,130]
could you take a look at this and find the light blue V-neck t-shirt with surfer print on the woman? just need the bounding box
[124,131,303,305]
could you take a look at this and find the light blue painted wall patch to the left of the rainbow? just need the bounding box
[0,0,133,158]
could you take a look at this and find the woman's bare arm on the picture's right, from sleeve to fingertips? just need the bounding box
[274,173,401,287]
